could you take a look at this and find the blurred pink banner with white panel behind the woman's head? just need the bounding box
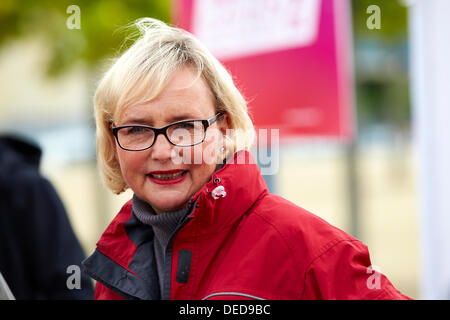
[173,0,354,140]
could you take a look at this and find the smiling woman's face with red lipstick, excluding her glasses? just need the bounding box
[115,67,227,213]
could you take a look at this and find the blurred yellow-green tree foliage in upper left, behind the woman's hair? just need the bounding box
[0,0,170,76]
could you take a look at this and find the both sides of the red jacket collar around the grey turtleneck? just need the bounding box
[92,150,268,262]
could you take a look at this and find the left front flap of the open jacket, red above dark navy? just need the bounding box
[82,200,160,300]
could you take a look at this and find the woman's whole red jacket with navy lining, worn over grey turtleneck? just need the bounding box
[84,151,408,299]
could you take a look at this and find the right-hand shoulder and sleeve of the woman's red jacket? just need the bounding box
[248,194,408,299]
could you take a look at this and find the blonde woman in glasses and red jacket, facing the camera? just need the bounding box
[84,18,407,299]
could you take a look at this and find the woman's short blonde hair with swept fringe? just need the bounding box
[94,18,255,194]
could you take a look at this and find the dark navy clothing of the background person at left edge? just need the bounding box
[0,136,93,300]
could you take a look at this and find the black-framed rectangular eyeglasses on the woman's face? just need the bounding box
[112,112,221,151]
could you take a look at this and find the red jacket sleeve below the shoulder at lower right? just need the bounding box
[302,240,410,300]
